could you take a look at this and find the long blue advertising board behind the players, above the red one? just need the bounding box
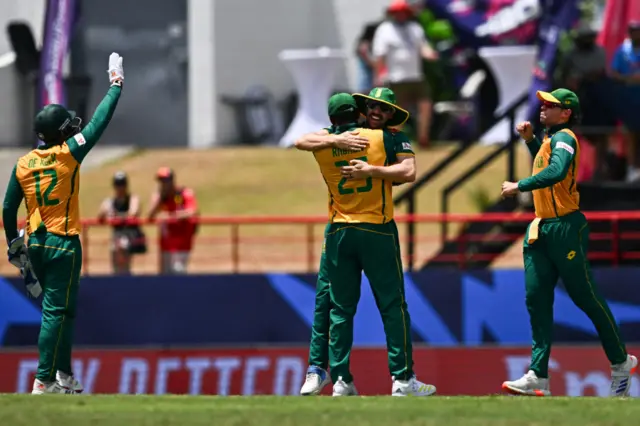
[0,268,640,347]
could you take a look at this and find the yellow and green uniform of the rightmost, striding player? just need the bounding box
[518,122,627,378]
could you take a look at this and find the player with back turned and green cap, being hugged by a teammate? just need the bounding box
[296,89,435,396]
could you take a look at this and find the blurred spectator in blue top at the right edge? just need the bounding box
[611,22,640,181]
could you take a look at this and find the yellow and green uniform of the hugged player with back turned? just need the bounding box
[310,125,414,383]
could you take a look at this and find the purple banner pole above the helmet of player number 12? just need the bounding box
[38,0,76,143]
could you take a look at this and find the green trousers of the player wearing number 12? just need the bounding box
[29,233,82,382]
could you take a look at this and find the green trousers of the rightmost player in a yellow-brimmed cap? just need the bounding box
[524,212,627,378]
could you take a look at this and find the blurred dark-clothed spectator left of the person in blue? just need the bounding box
[560,25,616,180]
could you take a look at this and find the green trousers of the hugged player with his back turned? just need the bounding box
[325,222,413,383]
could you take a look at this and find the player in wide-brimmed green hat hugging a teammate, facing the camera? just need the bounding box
[295,87,410,395]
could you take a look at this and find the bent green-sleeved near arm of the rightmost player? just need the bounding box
[518,132,577,192]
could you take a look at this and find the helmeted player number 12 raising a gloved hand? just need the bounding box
[2,53,124,394]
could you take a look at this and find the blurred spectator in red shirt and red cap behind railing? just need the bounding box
[149,167,198,274]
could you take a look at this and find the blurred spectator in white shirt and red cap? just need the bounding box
[373,0,437,148]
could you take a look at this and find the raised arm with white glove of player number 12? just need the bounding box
[67,53,124,163]
